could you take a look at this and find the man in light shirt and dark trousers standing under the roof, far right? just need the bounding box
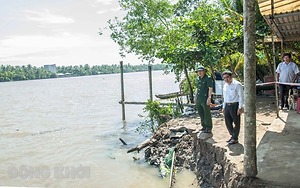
[276,53,299,109]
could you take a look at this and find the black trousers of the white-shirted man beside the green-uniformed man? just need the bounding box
[224,103,241,140]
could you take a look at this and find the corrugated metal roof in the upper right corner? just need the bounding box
[258,0,300,41]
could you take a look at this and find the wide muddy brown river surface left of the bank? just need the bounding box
[0,71,195,188]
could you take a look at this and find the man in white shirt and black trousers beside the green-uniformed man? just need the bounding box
[222,71,244,144]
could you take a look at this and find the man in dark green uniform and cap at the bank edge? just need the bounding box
[196,66,213,133]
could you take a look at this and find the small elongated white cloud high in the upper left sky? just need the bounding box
[25,9,74,24]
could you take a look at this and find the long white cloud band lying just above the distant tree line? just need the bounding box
[0,45,141,66]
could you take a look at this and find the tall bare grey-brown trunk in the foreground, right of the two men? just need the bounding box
[244,0,257,177]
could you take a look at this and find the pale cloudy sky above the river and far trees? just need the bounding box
[0,0,143,67]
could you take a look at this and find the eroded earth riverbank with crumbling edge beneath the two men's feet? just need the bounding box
[134,96,295,187]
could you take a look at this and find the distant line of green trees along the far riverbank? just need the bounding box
[0,64,164,82]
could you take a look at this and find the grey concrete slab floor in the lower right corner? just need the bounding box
[257,111,300,187]
